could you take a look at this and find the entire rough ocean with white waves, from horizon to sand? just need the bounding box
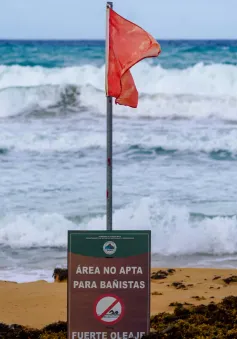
[0,40,237,282]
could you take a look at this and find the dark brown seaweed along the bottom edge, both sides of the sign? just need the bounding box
[0,296,237,339]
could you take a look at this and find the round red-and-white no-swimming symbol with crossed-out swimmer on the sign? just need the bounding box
[94,295,124,325]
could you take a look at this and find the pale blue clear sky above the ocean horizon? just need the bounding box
[0,0,237,39]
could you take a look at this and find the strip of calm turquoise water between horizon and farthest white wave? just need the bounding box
[0,40,237,69]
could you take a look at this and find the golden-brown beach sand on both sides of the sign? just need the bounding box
[0,268,237,328]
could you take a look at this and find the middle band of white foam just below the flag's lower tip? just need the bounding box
[0,121,237,155]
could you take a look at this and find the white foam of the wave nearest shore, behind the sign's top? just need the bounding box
[0,198,237,255]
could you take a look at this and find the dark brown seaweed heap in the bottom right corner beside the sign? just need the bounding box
[145,296,237,339]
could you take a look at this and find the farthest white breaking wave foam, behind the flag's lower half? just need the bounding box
[0,62,237,120]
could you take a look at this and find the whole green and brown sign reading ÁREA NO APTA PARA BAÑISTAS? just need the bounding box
[68,231,151,339]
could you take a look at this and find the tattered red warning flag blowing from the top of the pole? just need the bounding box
[106,7,161,108]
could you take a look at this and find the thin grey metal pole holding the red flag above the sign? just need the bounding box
[105,2,113,231]
